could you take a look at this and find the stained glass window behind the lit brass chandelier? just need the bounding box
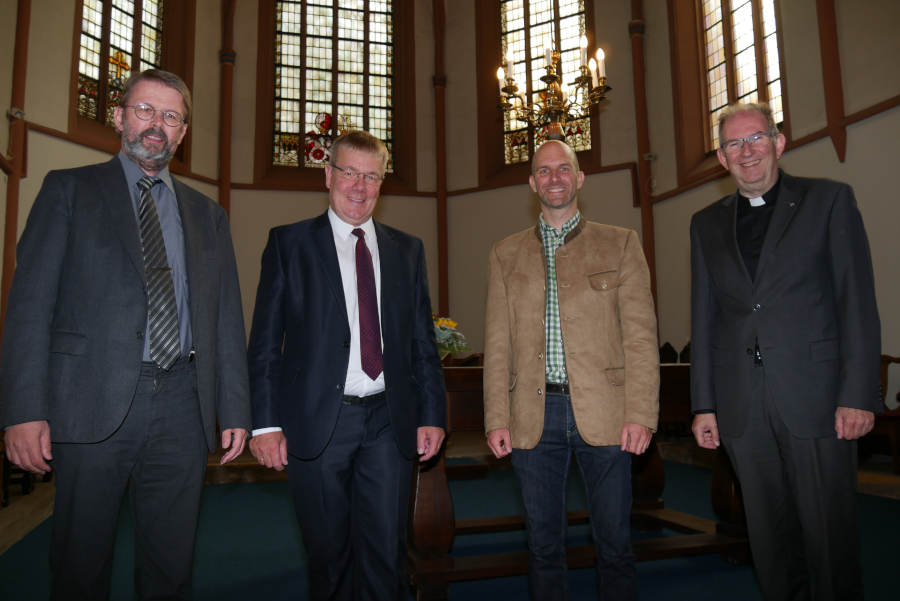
[500,0,591,165]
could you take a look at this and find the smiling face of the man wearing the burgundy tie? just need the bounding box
[325,146,384,225]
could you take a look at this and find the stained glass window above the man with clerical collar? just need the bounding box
[700,0,784,150]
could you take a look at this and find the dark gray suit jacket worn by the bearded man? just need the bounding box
[0,158,250,450]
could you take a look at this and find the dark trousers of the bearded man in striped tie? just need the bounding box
[50,360,207,601]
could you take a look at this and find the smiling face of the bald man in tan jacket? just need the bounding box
[528,141,584,227]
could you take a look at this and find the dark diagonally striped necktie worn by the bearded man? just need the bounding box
[138,175,181,369]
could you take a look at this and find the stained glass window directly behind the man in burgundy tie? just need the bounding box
[272,0,393,171]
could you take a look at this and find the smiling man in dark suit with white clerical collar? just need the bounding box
[691,104,881,601]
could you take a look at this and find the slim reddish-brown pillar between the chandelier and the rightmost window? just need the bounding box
[628,0,658,304]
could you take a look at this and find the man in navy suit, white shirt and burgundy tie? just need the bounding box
[248,131,445,601]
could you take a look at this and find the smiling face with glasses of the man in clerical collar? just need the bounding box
[716,110,785,198]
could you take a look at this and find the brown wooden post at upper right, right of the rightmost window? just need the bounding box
[816,0,847,163]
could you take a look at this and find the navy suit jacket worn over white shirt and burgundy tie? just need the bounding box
[248,213,446,459]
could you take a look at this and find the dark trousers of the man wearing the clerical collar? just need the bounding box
[722,367,863,601]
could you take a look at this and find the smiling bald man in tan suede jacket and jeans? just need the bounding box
[484,141,659,601]
